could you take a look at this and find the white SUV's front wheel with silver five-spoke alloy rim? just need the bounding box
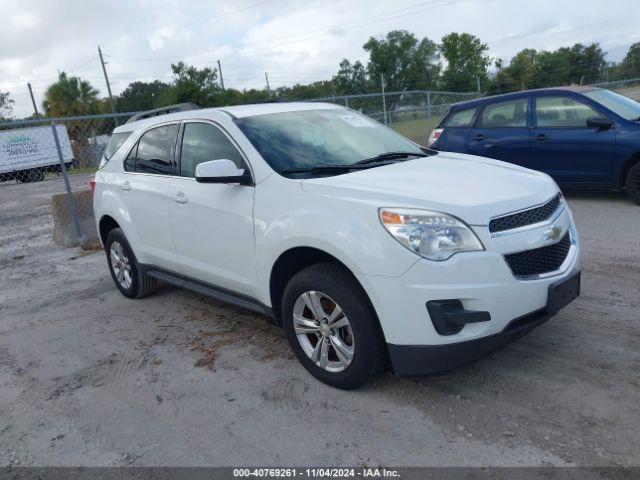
[282,262,386,389]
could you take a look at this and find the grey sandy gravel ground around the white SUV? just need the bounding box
[0,176,640,466]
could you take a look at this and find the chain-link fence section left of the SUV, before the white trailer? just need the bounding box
[0,114,131,255]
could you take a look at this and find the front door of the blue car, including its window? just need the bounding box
[531,93,616,185]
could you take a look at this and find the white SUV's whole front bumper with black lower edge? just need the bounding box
[356,204,580,374]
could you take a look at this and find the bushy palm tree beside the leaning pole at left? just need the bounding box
[42,72,100,117]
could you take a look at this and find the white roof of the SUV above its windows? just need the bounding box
[114,102,344,132]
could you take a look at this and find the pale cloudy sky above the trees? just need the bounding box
[0,0,640,117]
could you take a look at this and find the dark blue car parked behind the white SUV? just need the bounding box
[429,87,640,203]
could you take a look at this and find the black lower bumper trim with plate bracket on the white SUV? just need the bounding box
[387,272,580,375]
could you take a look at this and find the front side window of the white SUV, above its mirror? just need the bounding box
[180,123,245,177]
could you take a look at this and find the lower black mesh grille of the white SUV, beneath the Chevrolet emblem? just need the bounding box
[504,232,571,278]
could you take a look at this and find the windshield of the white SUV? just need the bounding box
[236,109,424,173]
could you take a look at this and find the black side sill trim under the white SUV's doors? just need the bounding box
[140,264,280,325]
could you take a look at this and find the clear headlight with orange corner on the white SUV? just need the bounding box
[380,208,484,261]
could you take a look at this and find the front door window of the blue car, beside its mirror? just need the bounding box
[536,96,601,127]
